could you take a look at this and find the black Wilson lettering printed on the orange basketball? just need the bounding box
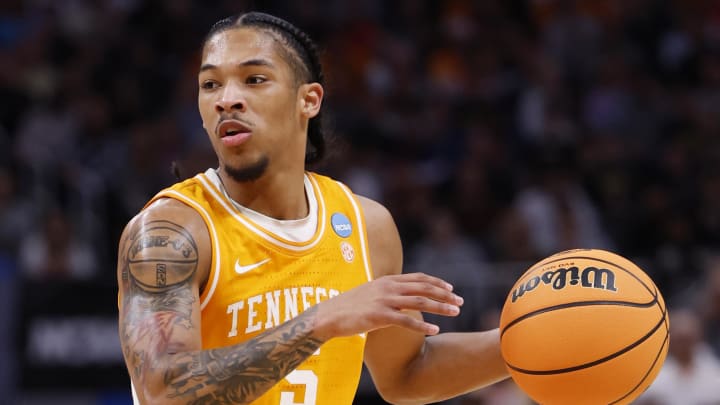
[512,267,617,302]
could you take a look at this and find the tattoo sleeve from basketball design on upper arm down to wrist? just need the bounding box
[119,221,323,404]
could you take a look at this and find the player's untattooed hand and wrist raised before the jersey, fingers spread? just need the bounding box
[315,273,463,341]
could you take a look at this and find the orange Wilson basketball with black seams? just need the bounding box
[500,249,669,405]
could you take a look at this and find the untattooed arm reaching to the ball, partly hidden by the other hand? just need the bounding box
[359,197,508,404]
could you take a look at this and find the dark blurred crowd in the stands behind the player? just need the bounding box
[0,0,720,405]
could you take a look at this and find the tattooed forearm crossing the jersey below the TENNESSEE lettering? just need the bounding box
[136,308,322,404]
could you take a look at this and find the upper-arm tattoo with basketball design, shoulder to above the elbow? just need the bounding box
[120,221,198,381]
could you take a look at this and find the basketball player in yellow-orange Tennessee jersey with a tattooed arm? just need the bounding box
[118,13,507,405]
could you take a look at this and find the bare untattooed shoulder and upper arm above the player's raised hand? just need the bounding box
[355,195,402,278]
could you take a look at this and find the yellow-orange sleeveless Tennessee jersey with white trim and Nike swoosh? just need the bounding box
[145,169,372,405]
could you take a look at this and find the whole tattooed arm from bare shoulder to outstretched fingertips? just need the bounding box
[118,199,466,404]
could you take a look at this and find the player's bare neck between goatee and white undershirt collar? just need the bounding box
[217,168,309,219]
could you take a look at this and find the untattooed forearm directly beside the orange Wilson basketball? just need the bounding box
[396,329,508,402]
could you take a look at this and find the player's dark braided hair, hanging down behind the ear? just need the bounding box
[203,12,326,164]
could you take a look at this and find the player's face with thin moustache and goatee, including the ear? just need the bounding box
[198,28,322,181]
